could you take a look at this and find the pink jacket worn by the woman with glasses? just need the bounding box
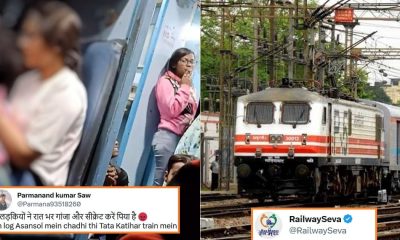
[156,71,198,136]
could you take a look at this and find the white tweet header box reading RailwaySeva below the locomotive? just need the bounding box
[251,208,377,240]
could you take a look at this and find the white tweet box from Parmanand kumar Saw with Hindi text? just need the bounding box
[0,187,179,234]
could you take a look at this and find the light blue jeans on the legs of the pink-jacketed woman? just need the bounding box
[153,130,180,186]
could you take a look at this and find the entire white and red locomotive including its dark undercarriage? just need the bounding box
[234,88,400,201]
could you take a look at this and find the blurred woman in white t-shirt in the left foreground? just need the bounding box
[0,1,87,186]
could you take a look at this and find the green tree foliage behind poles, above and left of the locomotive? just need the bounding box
[201,0,316,97]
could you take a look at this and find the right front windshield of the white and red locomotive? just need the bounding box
[282,103,310,124]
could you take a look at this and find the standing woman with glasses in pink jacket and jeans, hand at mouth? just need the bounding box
[152,48,198,186]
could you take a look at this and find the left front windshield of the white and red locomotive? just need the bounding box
[246,102,275,124]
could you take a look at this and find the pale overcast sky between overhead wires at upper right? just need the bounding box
[318,0,400,83]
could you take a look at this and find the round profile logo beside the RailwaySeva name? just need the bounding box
[255,212,282,238]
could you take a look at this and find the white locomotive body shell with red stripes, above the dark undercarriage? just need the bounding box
[235,88,384,164]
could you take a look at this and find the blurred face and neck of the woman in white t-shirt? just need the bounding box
[18,15,62,69]
